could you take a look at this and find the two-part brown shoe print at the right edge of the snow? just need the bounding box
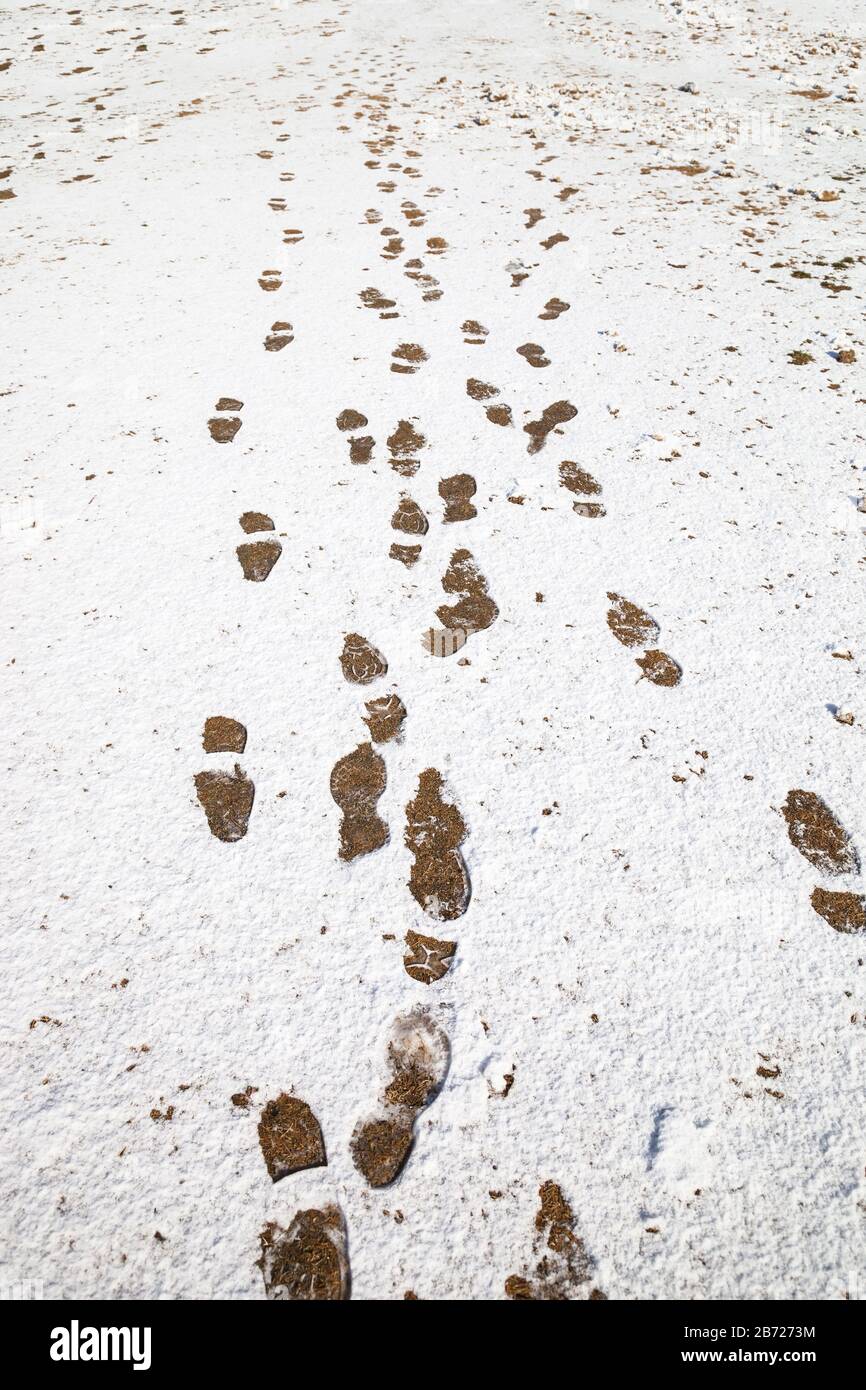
[781,787,866,935]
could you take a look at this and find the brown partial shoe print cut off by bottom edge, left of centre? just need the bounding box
[257,1207,350,1302]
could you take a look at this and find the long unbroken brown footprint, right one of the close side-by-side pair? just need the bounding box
[405,767,471,922]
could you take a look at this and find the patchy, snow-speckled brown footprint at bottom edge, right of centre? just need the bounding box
[505,1182,606,1302]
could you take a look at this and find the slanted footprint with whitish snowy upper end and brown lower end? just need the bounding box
[350,1009,450,1187]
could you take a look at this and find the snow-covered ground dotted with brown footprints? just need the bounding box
[0,0,866,1300]
